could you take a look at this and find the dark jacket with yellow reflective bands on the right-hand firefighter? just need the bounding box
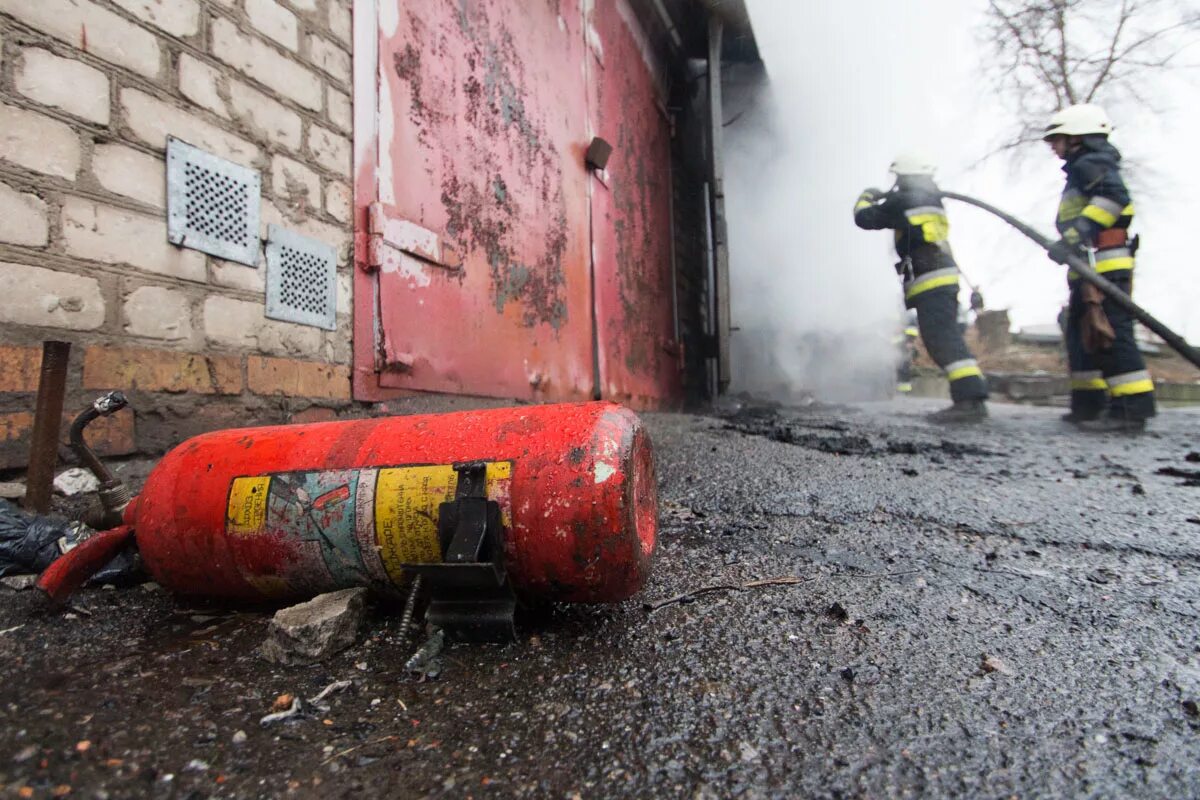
[1056,136,1133,275]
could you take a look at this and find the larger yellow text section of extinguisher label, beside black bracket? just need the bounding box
[374,462,512,581]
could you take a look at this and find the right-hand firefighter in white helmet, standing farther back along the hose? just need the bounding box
[1044,103,1154,433]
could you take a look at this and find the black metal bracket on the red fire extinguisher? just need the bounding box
[403,462,516,642]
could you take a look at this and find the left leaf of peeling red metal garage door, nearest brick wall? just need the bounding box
[355,0,593,399]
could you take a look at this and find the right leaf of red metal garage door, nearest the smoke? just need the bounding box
[588,0,682,408]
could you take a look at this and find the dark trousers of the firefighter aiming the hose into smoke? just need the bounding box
[905,273,988,403]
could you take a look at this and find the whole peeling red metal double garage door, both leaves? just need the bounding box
[354,0,680,407]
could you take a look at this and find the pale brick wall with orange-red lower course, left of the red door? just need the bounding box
[0,0,353,468]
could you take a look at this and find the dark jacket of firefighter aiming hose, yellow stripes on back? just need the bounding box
[854,176,956,276]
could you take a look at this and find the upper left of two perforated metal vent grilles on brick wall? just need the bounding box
[167,139,262,266]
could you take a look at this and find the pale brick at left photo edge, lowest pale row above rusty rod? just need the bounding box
[0,263,104,331]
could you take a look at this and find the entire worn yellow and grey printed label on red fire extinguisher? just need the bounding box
[226,462,512,595]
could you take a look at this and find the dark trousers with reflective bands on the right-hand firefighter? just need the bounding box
[1067,270,1154,420]
